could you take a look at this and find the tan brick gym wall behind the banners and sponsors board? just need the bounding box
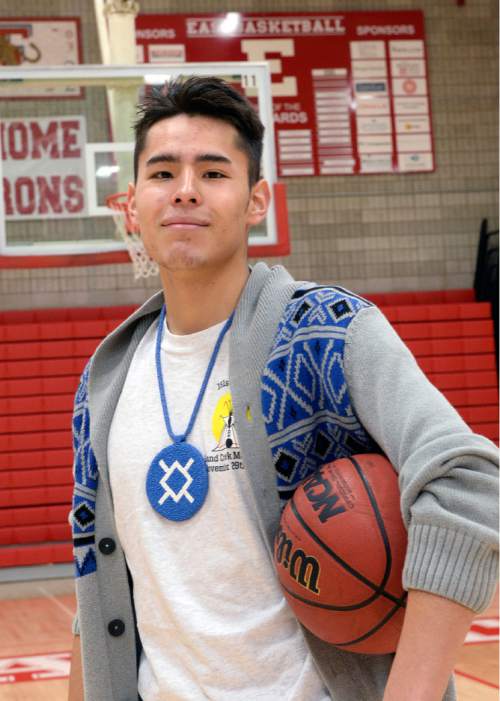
[0,0,498,309]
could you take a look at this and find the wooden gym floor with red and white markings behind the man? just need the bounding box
[0,579,499,701]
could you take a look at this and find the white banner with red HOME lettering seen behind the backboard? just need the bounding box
[0,117,86,220]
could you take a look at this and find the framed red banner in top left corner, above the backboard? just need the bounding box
[0,17,83,99]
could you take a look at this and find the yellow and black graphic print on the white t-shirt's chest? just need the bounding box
[205,392,244,472]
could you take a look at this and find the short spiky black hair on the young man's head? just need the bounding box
[134,76,264,187]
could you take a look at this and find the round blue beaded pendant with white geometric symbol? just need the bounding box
[146,442,208,521]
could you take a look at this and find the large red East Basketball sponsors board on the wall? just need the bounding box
[136,11,434,176]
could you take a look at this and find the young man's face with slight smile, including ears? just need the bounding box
[129,114,269,272]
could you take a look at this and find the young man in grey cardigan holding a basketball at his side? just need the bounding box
[70,78,497,701]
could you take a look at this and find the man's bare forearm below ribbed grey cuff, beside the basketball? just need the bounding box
[384,590,474,701]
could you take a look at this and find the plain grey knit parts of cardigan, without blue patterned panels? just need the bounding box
[75,263,498,701]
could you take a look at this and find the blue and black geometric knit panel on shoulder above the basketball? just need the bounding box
[261,287,374,499]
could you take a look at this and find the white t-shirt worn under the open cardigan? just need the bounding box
[108,323,329,701]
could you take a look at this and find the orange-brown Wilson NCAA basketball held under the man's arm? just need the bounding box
[274,454,407,654]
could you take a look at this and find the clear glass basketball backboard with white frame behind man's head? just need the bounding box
[0,63,288,267]
